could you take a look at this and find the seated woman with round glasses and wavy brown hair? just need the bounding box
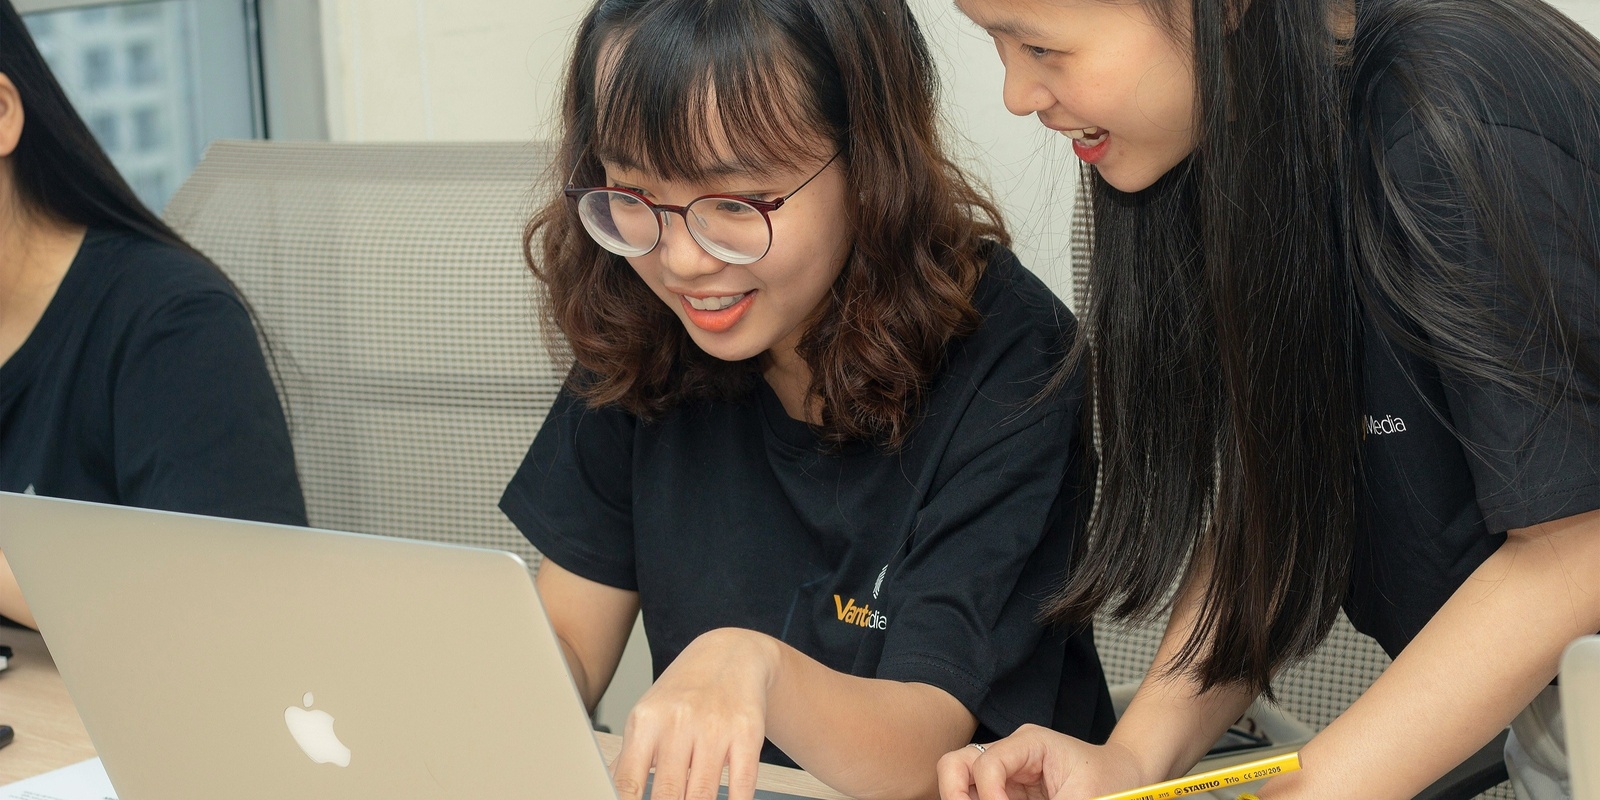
[501,0,1110,800]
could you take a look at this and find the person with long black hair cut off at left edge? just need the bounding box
[0,0,306,626]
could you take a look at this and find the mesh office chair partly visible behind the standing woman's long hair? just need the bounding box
[1072,176,1517,800]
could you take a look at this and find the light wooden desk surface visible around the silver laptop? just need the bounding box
[0,627,850,800]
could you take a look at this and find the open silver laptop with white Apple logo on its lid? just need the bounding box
[0,494,616,800]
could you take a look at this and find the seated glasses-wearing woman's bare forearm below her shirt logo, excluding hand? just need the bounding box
[752,638,978,800]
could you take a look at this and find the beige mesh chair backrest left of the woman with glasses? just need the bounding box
[165,142,565,566]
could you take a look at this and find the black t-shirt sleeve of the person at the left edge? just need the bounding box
[112,290,306,525]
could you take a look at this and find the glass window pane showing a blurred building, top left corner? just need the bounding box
[22,0,261,211]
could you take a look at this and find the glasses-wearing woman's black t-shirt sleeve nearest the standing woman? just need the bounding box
[878,398,1077,734]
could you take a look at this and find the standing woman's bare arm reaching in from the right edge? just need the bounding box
[1261,515,1600,800]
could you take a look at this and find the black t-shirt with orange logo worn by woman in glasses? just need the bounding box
[501,246,1114,763]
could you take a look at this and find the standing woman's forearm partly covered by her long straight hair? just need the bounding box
[1107,576,1254,782]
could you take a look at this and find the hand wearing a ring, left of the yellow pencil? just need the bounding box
[939,725,1149,800]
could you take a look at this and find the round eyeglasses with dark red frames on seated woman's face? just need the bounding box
[563,152,838,264]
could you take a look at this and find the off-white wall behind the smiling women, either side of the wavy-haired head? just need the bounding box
[312,0,1077,305]
